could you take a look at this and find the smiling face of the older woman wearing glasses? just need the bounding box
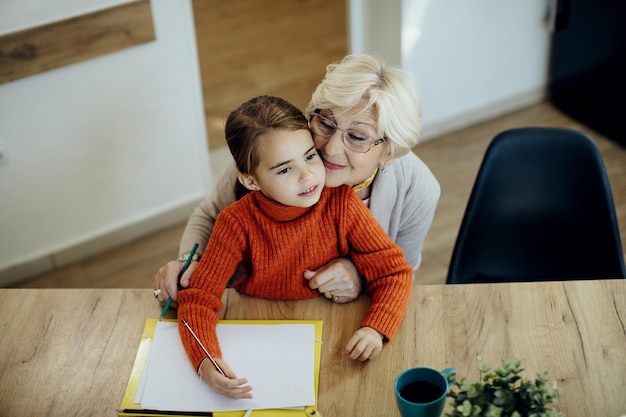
[313,104,387,187]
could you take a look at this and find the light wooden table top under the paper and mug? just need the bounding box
[0,280,626,417]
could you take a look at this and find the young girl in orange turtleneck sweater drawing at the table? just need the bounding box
[178,96,412,398]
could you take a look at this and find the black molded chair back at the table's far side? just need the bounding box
[446,127,626,284]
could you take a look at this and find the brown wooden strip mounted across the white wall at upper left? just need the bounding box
[0,0,155,84]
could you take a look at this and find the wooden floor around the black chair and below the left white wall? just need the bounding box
[21,99,626,288]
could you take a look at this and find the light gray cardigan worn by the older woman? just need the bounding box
[179,152,441,270]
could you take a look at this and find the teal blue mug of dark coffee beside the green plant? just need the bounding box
[394,367,456,417]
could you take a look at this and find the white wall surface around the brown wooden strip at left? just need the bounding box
[0,0,211,285]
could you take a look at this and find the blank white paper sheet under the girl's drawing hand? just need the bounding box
[135,322,315,411]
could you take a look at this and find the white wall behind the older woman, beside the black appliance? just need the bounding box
[349,0,550,140]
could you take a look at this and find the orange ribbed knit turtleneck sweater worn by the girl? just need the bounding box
[178,186,413,369]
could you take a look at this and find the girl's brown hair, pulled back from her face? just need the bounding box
[225,96,309,175]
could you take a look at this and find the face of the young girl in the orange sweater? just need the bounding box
[242,129,325,207]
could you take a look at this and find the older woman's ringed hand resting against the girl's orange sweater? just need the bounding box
[303,258,362,303]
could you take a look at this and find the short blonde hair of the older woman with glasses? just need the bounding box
[305,55,422,158]
